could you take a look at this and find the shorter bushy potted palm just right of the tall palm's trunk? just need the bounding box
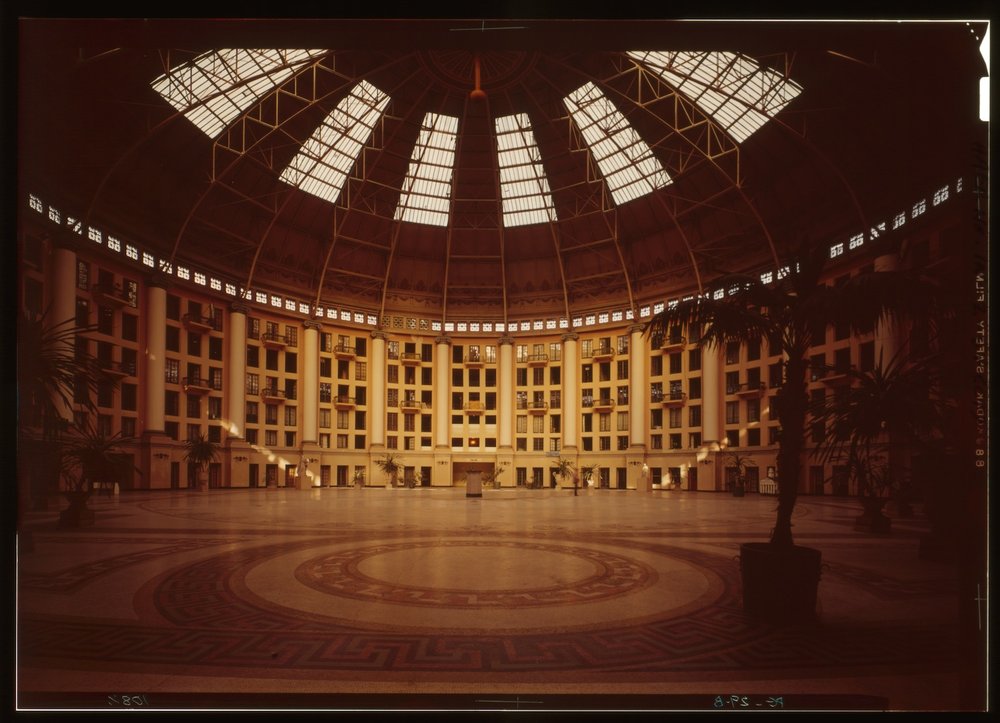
[810,350,951,532]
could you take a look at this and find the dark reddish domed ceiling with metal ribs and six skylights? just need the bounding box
[18,19,986,328]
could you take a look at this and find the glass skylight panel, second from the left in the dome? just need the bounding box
[281,80,389,203]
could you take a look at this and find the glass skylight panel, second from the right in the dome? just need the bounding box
[563,83,673,206]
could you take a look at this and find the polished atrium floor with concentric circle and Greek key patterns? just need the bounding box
[11,488,961,710]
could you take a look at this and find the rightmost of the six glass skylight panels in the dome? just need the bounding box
[628,50,802,143]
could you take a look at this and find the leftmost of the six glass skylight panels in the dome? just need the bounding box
[152,48,327,138]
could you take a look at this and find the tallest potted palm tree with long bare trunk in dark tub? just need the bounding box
[645,245,938,621]
